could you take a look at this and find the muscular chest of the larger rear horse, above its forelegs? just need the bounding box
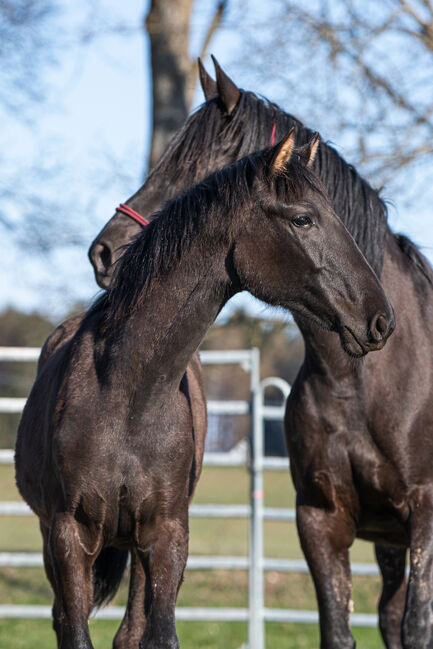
[286,386,409,545]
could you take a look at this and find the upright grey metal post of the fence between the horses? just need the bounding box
[248,347,265,649]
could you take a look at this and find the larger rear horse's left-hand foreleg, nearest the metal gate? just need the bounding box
[297,504,355,649]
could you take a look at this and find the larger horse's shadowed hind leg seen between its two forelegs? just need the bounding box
[375,545,407,649]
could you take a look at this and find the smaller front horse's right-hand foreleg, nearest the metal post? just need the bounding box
[139,512,188,649]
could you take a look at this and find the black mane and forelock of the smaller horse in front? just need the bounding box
[89,150,329,327]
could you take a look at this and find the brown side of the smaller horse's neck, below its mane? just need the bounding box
[106,239,231,408]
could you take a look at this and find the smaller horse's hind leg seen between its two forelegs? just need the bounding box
[113,550,146,649]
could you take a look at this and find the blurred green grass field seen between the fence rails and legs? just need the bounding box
[0,466,383,649]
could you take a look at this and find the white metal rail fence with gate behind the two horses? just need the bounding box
[0,347,379,649]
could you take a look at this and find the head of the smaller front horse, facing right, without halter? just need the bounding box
[233,129,395,357]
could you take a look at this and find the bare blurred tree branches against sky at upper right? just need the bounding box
[233,0,433,192]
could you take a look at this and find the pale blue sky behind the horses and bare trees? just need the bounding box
[0,0,433,319]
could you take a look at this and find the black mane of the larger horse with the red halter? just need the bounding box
[143,91,410,275]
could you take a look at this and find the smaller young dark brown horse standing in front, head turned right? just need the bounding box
[16,133,394,649]
